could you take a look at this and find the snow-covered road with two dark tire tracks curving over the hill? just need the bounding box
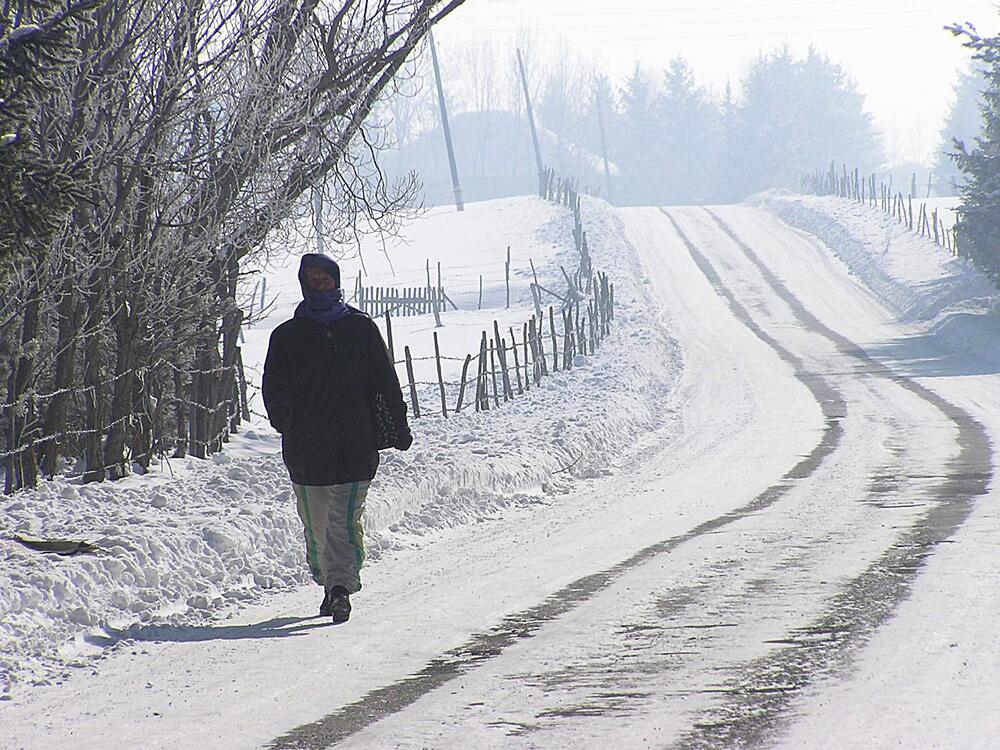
[0,201,1000,750]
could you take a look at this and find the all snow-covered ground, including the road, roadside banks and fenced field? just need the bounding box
[0,193,1000,750]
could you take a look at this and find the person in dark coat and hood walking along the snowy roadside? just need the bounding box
[261,253,413,623]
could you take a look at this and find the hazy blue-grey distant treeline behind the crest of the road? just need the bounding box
[382,48,884,205]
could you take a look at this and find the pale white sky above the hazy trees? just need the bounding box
[435,0,1000,162]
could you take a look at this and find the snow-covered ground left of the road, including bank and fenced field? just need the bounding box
[0,198,679,698]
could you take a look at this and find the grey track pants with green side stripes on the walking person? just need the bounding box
[292,482,371,594]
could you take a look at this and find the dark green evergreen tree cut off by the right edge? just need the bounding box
[951,24,1000,286]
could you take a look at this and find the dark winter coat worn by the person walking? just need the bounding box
[262,308,412,485]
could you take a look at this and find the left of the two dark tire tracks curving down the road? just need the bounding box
[268,214,846,750]
